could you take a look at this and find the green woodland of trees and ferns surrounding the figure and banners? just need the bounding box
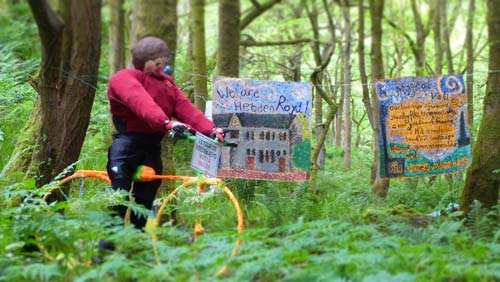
[0,0,500,281]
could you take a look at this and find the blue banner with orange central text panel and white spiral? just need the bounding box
[375,74,471,178]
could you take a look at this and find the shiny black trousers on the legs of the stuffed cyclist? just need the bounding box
[106,133,163,229]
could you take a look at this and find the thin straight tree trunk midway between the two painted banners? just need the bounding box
[342,5,352,170]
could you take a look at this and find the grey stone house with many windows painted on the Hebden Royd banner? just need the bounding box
[213,113,303,176]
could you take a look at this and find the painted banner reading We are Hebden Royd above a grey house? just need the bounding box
[212,77,312,181]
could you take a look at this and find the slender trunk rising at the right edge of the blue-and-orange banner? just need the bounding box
[465,0,476,131]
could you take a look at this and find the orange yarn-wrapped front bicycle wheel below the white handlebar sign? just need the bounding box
[152,177,245,272]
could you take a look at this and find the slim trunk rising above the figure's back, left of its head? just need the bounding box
[108,0,125,76]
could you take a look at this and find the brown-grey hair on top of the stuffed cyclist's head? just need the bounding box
[132,36,171,70]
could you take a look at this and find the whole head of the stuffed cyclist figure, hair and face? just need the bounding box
[132,36,170,74]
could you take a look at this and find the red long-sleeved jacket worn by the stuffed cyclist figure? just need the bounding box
[108,69,214,135]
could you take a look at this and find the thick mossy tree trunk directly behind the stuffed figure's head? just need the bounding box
[130,0,178,194]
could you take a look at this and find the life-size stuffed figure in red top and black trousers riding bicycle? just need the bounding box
[107,36,224,229]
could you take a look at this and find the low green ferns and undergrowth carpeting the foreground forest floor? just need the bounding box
[0,144,500,281]
